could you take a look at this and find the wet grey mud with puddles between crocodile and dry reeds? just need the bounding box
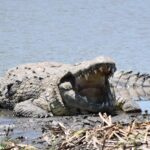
[0,109,150,149]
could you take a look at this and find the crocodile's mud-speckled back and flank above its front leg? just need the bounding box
[0,62,69,108]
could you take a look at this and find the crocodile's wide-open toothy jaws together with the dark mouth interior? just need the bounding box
[60,57,116,112]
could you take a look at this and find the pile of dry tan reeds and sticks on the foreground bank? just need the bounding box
[43,113,150,150]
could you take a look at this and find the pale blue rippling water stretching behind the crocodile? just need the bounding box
[0,0,150,74]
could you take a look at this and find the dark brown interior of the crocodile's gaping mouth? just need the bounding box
[75,64,114,105]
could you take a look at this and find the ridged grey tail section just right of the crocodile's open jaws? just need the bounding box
[110,71,150,88]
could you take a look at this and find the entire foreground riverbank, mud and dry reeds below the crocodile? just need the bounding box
[0,113,150,149]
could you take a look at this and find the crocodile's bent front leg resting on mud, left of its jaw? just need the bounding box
[14,87,68,117]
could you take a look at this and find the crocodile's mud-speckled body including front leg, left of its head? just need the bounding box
[0,62,69,117]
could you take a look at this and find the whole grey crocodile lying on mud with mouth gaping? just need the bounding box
[0,56,150,117]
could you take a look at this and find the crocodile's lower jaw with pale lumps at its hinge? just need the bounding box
[59,82,115,113]
